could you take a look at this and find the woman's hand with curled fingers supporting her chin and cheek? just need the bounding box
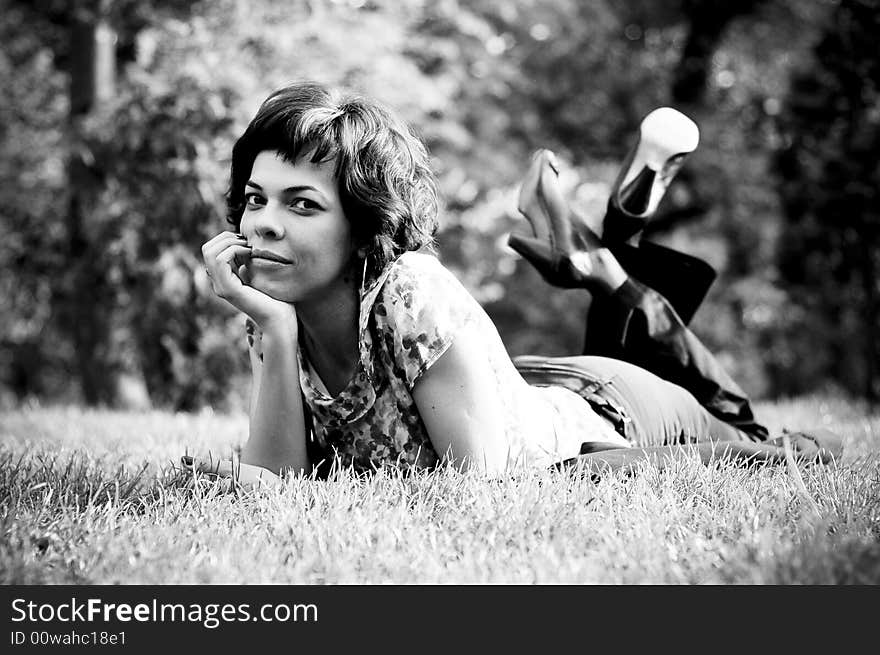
[202,231,296,329]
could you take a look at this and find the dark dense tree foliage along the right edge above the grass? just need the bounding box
[777,0,880,400]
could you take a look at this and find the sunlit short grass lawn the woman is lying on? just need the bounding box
[0,398,880,584]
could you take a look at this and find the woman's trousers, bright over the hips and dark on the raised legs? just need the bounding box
[517,243,768,446]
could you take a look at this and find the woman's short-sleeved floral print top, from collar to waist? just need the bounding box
[249,252,629,471]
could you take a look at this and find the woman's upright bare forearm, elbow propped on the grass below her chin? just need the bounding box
[241,326,311,473]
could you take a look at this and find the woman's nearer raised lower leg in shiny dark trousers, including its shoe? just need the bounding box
[510,151,767,441]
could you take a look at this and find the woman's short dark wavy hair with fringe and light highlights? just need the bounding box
[226,82,439,275]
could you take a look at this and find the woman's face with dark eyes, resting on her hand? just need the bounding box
[241,151,354,302]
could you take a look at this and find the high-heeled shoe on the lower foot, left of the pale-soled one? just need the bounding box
[507,150,602,289]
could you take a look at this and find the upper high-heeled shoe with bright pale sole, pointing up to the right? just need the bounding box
[602,107,700,244]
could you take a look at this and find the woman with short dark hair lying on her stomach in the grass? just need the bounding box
[199,83,844,480]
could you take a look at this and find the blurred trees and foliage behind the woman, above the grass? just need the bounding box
[0,0,880,411]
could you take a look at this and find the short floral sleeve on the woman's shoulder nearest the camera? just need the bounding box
[374,255,476,390]
